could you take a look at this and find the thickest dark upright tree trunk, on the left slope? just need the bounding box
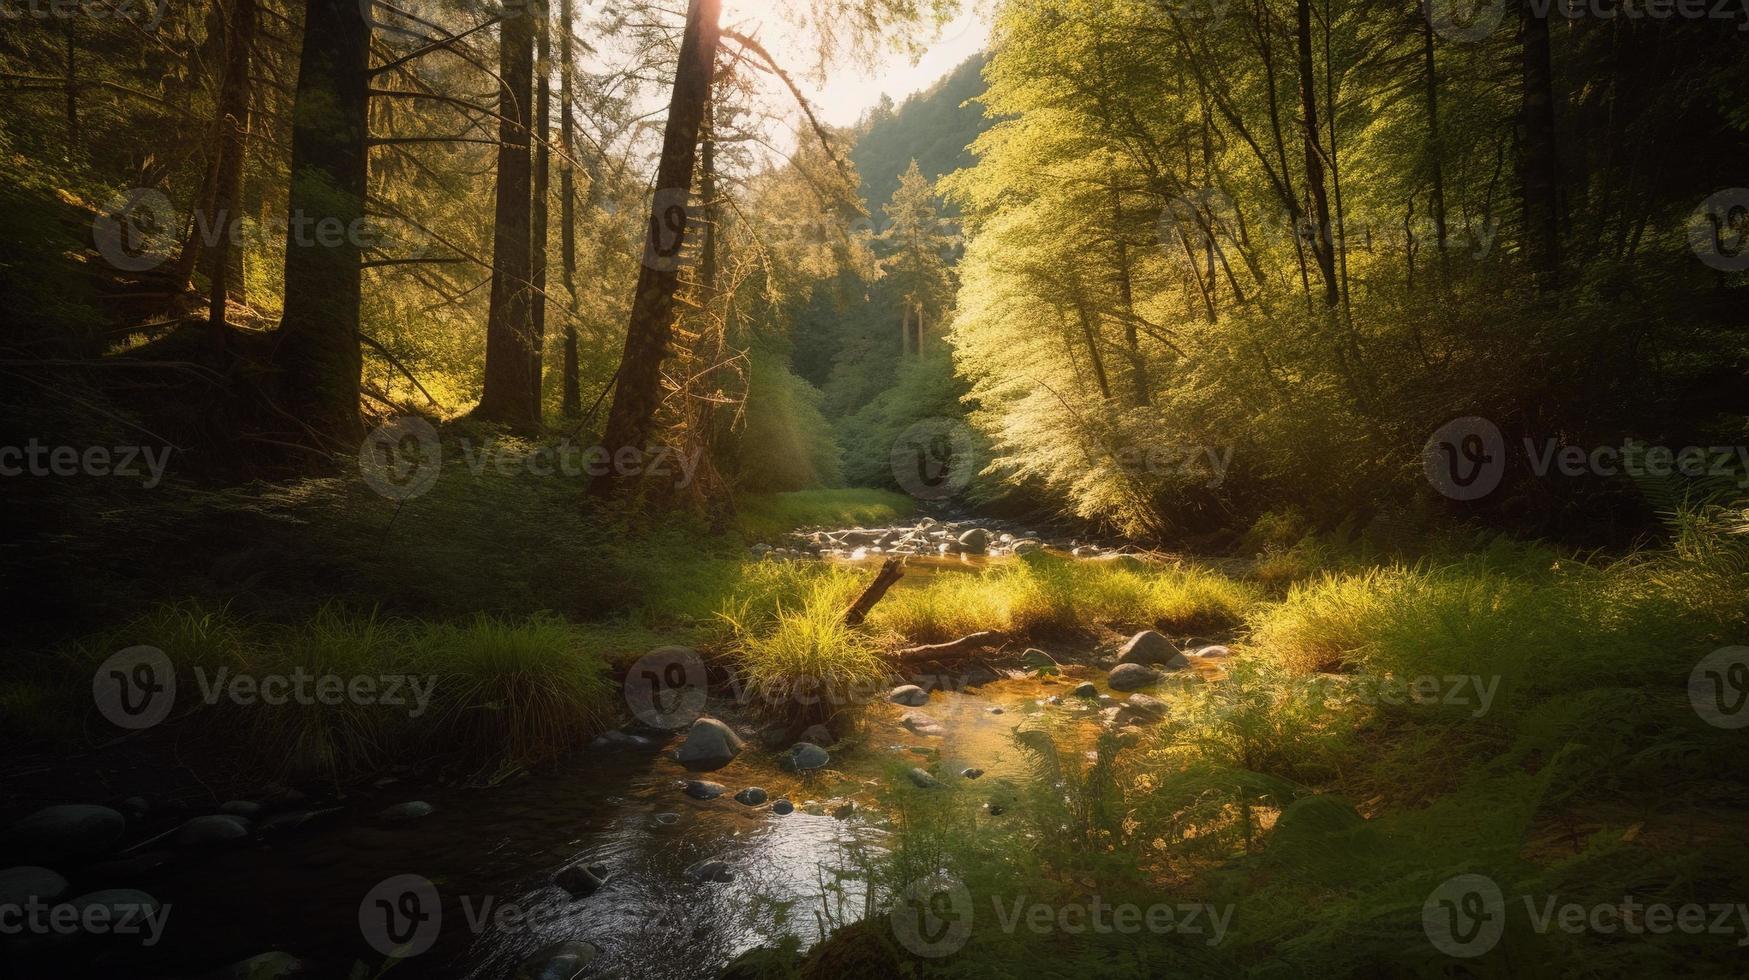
[273,0,371,448]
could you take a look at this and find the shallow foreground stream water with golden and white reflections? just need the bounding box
[30,665,1224,980]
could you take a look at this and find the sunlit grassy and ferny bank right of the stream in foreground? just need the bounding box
[790,518,1749,978]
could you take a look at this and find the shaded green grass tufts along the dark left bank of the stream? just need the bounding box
[44,602,619,779]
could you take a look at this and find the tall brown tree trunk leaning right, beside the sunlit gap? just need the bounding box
[589,0,722,497]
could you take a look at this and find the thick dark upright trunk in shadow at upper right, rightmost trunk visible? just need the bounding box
[1520,0,1560,289]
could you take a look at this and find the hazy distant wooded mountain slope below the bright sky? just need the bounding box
[850,54,990,215]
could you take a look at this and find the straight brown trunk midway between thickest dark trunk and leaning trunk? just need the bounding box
[474,4,539,431]
